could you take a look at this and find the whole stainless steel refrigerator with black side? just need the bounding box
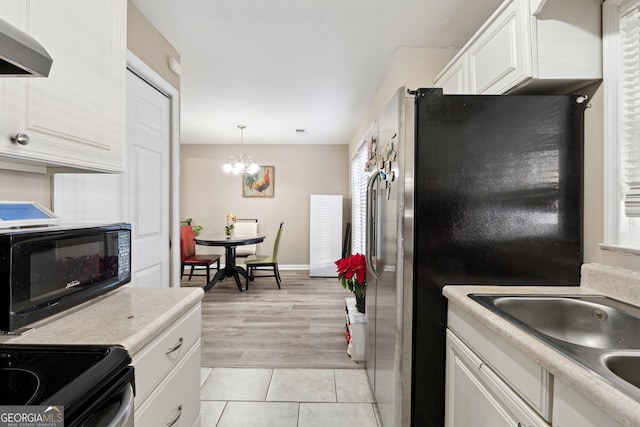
[365,88,586,427]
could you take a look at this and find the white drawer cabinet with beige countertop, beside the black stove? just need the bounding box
[0,287,204,426]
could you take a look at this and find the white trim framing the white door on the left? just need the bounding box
[127,50,180,287]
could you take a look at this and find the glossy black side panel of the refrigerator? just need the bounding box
[412,90,584,427]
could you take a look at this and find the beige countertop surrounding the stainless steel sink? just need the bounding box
[443,266,640,427]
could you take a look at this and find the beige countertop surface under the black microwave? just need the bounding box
[0,287,204,356]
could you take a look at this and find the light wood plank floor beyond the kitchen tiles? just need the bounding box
[182,271,364,369]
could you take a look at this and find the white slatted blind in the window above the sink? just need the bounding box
[618,0,640,217]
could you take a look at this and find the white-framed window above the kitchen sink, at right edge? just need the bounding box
[603,0,640,254]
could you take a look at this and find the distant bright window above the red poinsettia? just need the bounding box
[351,142,368,254]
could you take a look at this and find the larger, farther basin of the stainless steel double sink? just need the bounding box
[472,295,640,349]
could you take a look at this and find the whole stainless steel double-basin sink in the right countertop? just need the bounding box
[469,294,640,401]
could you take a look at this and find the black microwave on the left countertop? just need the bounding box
[0,223,131,333]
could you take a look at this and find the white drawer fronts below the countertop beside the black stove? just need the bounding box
[133,303,201,427]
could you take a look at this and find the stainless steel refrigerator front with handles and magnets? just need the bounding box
[365,90,403,426]
